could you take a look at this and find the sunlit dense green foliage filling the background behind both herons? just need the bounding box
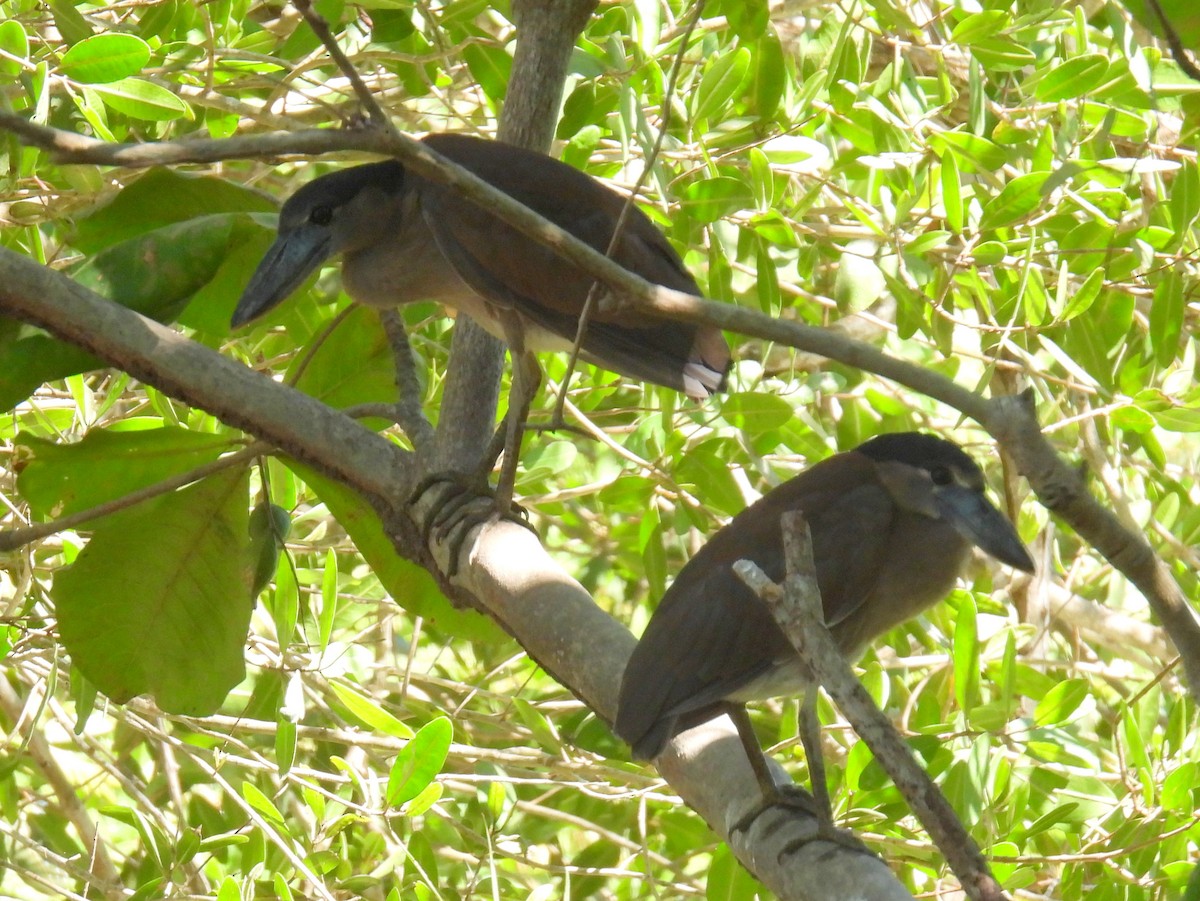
[0,0,1200,900]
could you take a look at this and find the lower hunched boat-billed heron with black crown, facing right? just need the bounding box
[614,432,1033,830]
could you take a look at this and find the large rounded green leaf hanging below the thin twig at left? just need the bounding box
[52,469,252,716]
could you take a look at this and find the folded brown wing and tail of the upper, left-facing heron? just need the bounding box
[420,134,730,389]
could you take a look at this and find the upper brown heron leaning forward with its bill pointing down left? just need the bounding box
[232,134,730,506]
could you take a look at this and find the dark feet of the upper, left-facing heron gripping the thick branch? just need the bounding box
[408,471,538,578]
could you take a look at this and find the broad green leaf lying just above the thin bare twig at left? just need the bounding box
[16,429,234,518]
